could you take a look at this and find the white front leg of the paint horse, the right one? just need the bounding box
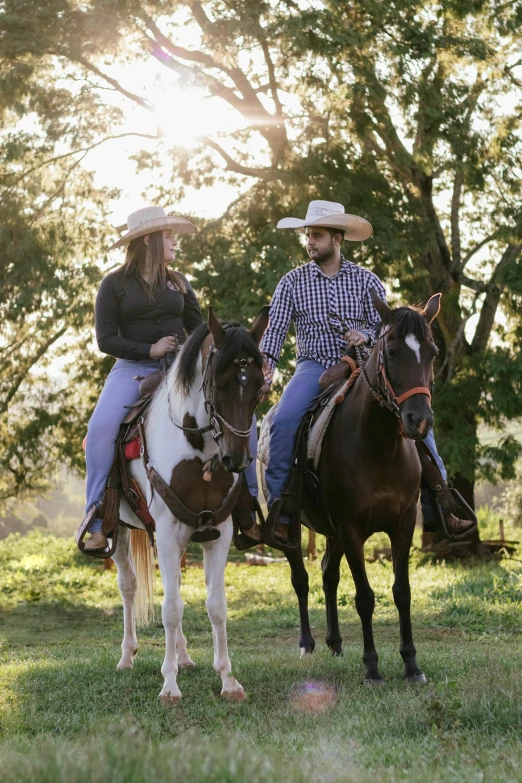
[202,517,246,701]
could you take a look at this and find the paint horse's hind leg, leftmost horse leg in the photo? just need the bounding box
[112,525,138,669]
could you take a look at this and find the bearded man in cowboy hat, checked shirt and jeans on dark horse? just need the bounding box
[254,201,474,545]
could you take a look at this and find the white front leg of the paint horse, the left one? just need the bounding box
[156,516,190,704]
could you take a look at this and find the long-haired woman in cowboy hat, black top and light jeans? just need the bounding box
[84,207,257,552]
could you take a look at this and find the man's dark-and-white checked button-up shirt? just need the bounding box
[261,256,386,377]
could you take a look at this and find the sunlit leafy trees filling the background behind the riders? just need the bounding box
[0,0,522,508]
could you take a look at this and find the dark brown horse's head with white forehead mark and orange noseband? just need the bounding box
[372,294,441,440]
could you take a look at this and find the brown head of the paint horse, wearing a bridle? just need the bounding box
[202,307,269,473]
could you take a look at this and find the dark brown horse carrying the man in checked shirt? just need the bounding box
[287,294,440,683]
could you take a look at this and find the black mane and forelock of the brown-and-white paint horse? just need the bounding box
[174,321,263,394]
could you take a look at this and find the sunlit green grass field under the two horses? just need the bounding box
[0,533,522,783]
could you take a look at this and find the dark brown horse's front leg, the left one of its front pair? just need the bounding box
[342,531,384,685]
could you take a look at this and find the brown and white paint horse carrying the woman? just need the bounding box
[114,307,268,703]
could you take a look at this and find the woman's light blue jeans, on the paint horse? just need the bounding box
[85,359,159,533]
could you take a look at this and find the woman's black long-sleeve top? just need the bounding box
[94,267,203,361]
